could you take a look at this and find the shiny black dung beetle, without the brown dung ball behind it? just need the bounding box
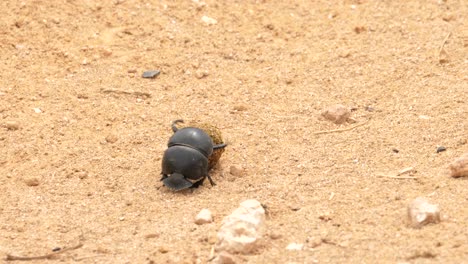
[161,119,226,191]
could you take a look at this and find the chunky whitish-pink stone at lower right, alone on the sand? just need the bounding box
[408,197,440,228]
